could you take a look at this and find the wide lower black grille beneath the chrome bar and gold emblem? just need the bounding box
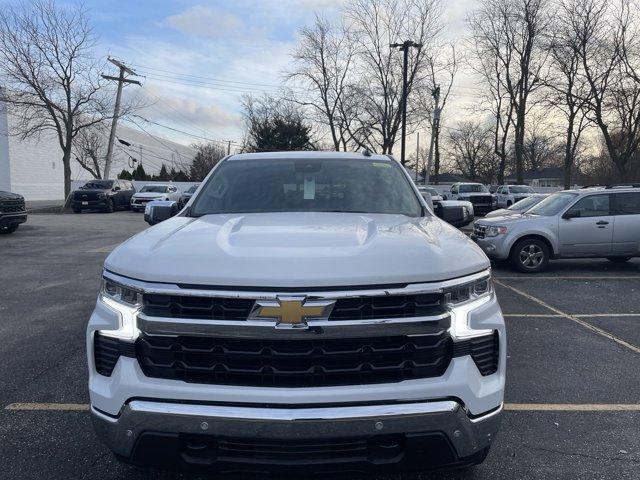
[136,328,453,387]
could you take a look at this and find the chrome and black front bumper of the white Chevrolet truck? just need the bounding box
[91,399,502,471]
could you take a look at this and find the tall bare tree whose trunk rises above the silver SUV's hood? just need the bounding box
[468,0,551,182]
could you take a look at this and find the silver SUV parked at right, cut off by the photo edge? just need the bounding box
[472,185,640,273]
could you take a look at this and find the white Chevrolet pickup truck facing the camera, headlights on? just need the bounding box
[87,152,506,476]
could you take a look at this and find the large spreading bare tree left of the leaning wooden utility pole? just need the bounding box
[0,0,107,196]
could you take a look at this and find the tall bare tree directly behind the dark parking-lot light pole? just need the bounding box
[345,0,442,153]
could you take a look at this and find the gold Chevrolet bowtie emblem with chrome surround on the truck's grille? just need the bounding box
[249,296,336,328]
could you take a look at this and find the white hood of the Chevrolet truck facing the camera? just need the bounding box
[105,212,489,287]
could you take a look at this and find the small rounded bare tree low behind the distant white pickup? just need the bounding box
[448,120,496,181]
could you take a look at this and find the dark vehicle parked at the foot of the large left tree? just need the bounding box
[71,180,136,213]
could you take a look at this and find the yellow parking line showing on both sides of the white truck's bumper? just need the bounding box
[4,403,640,412]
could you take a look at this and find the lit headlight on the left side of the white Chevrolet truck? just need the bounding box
[100,278,142,340]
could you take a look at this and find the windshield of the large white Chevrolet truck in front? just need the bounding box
[191,159,422,217]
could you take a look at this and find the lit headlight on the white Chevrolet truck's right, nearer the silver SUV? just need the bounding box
[444,275,493,339]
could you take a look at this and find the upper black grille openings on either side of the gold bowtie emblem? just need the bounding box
[143,294,443,321]
